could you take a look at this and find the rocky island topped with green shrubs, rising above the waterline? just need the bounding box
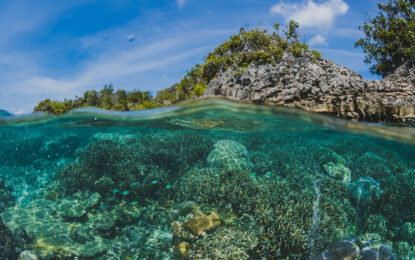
[34,21,415,122]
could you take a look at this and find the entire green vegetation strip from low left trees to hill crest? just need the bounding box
[34,21,321,115]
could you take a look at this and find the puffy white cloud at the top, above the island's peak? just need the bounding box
[271,0,349,30]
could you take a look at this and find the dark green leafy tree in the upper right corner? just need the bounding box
[355,0,415,76]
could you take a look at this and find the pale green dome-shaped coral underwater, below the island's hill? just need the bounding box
[207,140,252,171]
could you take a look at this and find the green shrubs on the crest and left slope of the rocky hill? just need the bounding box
[171,21,321,101]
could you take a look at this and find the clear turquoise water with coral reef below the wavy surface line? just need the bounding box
[0,100,415,259]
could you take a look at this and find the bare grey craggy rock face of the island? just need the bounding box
[204,53,415,122]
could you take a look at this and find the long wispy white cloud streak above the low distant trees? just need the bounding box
[15,41,211,97]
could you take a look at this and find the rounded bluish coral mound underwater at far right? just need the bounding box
[348,177,382,209]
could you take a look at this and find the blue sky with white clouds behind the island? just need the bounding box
[0,0,377,114]
